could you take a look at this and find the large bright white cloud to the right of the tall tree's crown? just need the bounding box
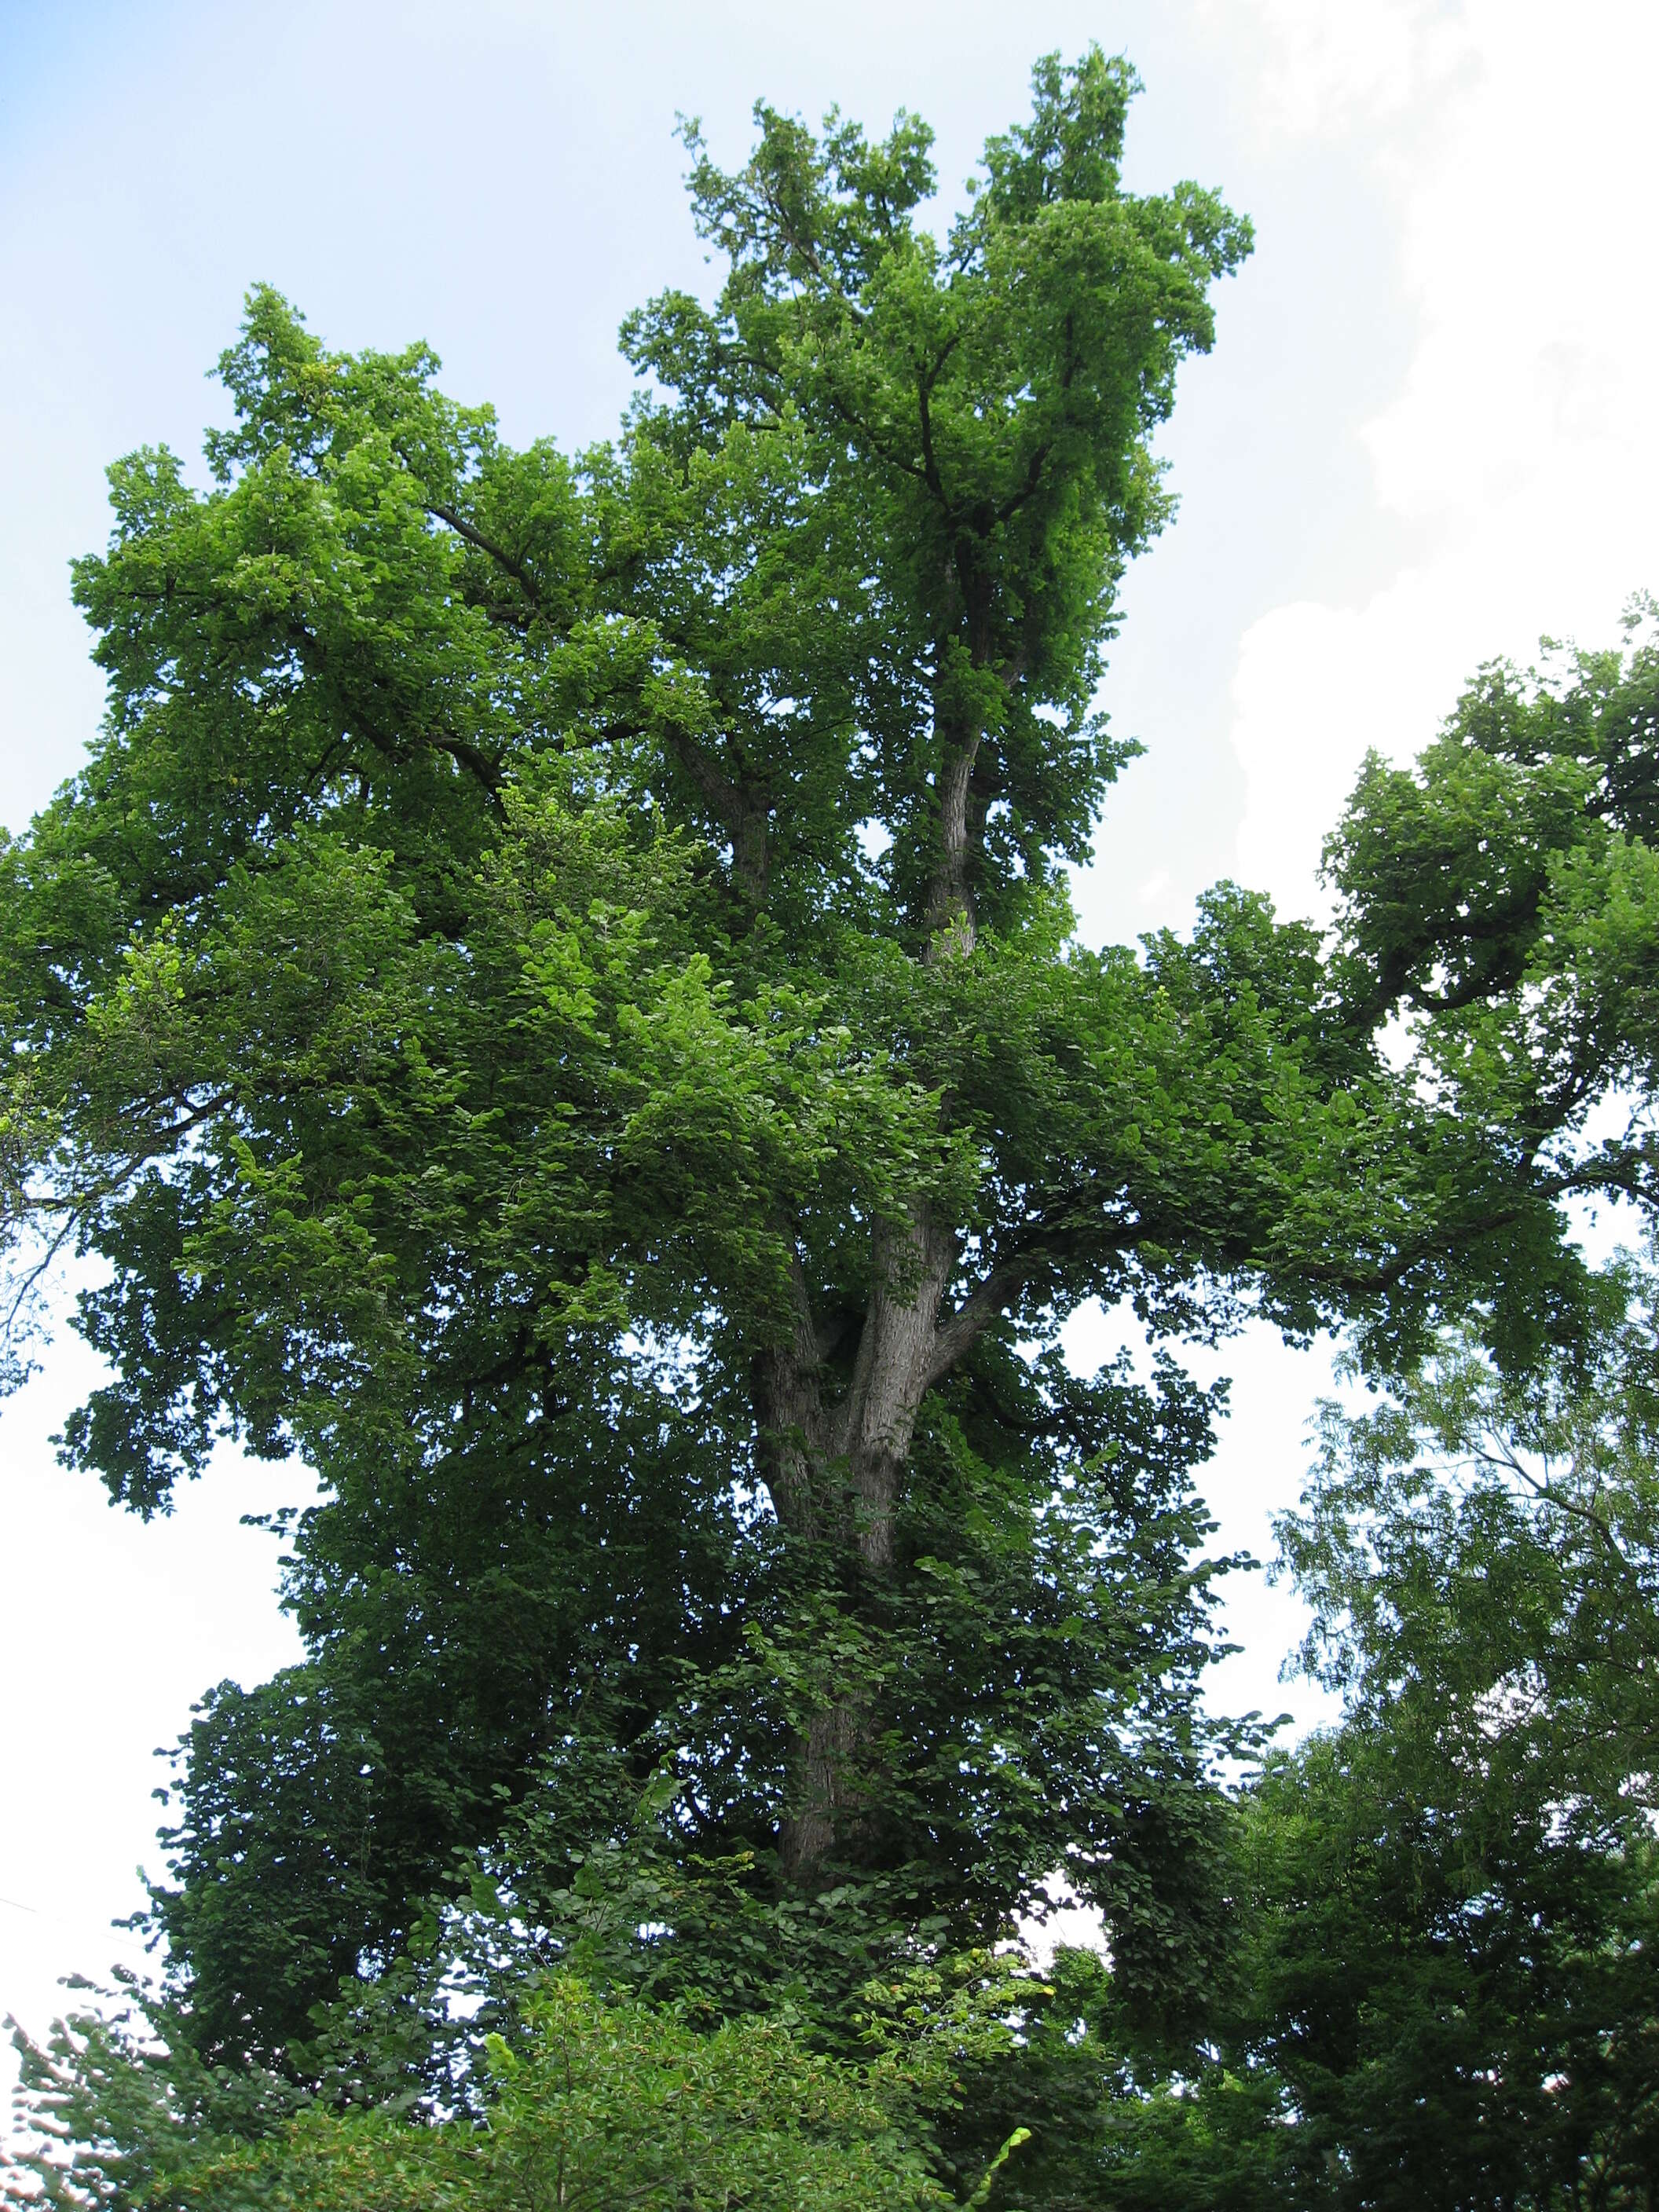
[1232,0,1659,911]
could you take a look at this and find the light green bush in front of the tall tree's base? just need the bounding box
[16,1973,1039,2212]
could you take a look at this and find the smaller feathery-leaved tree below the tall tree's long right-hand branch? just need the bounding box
[1252,1300,1659,2207]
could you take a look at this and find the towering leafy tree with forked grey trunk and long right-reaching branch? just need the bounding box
[0,53,1659,2201]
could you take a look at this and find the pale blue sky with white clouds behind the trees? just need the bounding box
[0,0,1659,2070]
